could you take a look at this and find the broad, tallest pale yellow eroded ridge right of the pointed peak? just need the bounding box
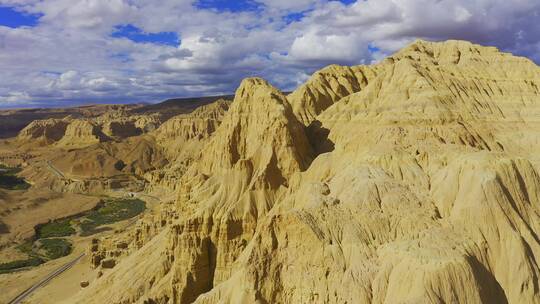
[196,41,540,303]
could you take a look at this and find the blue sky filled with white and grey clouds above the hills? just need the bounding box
[0,0,540,108]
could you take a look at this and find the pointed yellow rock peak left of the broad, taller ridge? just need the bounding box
[74,78,312,303]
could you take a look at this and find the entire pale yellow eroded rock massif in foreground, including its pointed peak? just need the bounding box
[66,41,540,304]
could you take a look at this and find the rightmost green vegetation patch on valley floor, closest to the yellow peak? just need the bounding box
[81,199,146,236]
